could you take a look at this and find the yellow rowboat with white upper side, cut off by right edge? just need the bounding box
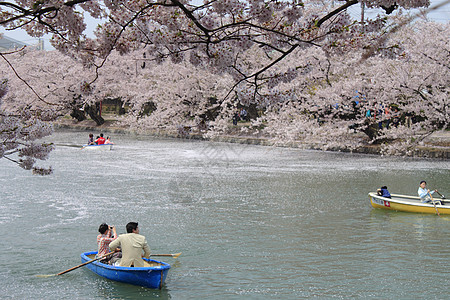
[369,193,450,215]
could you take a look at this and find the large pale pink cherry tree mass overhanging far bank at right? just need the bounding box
[255,22,450,155]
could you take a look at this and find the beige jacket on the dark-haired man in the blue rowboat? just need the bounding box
[109,233,150,267]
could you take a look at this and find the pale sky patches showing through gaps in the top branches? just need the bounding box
[0,0,450,50]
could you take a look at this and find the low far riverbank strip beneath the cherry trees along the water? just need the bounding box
[54,118,450,160]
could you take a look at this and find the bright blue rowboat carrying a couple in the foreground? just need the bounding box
[81,251,170,289]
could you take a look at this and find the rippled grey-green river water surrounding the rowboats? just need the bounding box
[0,132,450,299]
